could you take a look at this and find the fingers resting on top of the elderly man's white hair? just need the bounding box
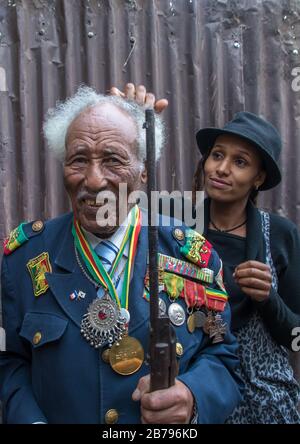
[110,83,168,113]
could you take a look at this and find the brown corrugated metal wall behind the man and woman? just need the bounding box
[0,0,300,406]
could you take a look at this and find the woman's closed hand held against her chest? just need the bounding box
[233,261,272,302]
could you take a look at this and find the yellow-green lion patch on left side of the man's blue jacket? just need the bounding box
[27,253,52,296]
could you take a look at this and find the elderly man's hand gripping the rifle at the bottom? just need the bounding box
[132,375,194,424]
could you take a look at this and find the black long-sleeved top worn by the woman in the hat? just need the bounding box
[204,199,300,348]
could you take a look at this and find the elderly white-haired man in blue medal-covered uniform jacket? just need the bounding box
[0,87,241,424]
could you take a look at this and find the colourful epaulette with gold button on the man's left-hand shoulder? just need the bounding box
[4,220,44,256]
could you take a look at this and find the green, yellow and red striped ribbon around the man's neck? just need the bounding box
[72,205,141,309]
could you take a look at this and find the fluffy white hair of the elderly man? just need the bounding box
[43,86,165,161]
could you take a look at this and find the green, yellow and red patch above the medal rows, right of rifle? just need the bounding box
[180,229,212,268]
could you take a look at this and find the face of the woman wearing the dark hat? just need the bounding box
[204,134,266,203]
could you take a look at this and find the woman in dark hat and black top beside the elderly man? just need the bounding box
[194,112,300,424]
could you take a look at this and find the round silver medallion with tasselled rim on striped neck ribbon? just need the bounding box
[72,206,141,348]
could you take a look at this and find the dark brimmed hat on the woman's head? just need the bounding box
[196,111,281,190]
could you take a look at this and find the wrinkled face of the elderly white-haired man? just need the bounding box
[64,103,146,237]
